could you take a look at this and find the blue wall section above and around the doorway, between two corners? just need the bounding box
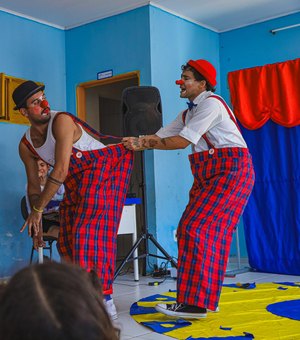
[66,6,151,113]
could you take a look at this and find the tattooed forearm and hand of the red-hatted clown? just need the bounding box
[122,135,191,151]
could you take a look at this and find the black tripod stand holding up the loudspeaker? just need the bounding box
[114,151,177,279]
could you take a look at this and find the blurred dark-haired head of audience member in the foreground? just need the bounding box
[0,262,119,340]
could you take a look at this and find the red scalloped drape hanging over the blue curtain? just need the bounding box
[228,59,300,130]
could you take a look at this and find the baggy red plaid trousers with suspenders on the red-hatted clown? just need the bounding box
[177,96,254,310]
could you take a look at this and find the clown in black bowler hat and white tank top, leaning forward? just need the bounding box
[12,80,133,318]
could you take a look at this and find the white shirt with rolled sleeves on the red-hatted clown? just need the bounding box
[156,91,247,152]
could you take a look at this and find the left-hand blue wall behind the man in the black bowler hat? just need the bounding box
[0,11,66,277]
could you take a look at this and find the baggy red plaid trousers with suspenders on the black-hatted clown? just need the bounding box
[22,113,133,294]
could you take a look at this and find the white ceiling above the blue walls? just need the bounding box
[0,0,300,32]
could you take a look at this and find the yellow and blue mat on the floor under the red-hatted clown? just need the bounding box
[130,282,300,340]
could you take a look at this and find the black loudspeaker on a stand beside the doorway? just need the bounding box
[122,86,162,137]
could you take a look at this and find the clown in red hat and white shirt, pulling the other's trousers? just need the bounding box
[123,59,254,319]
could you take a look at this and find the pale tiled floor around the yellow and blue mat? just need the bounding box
[113,266,300,340]
